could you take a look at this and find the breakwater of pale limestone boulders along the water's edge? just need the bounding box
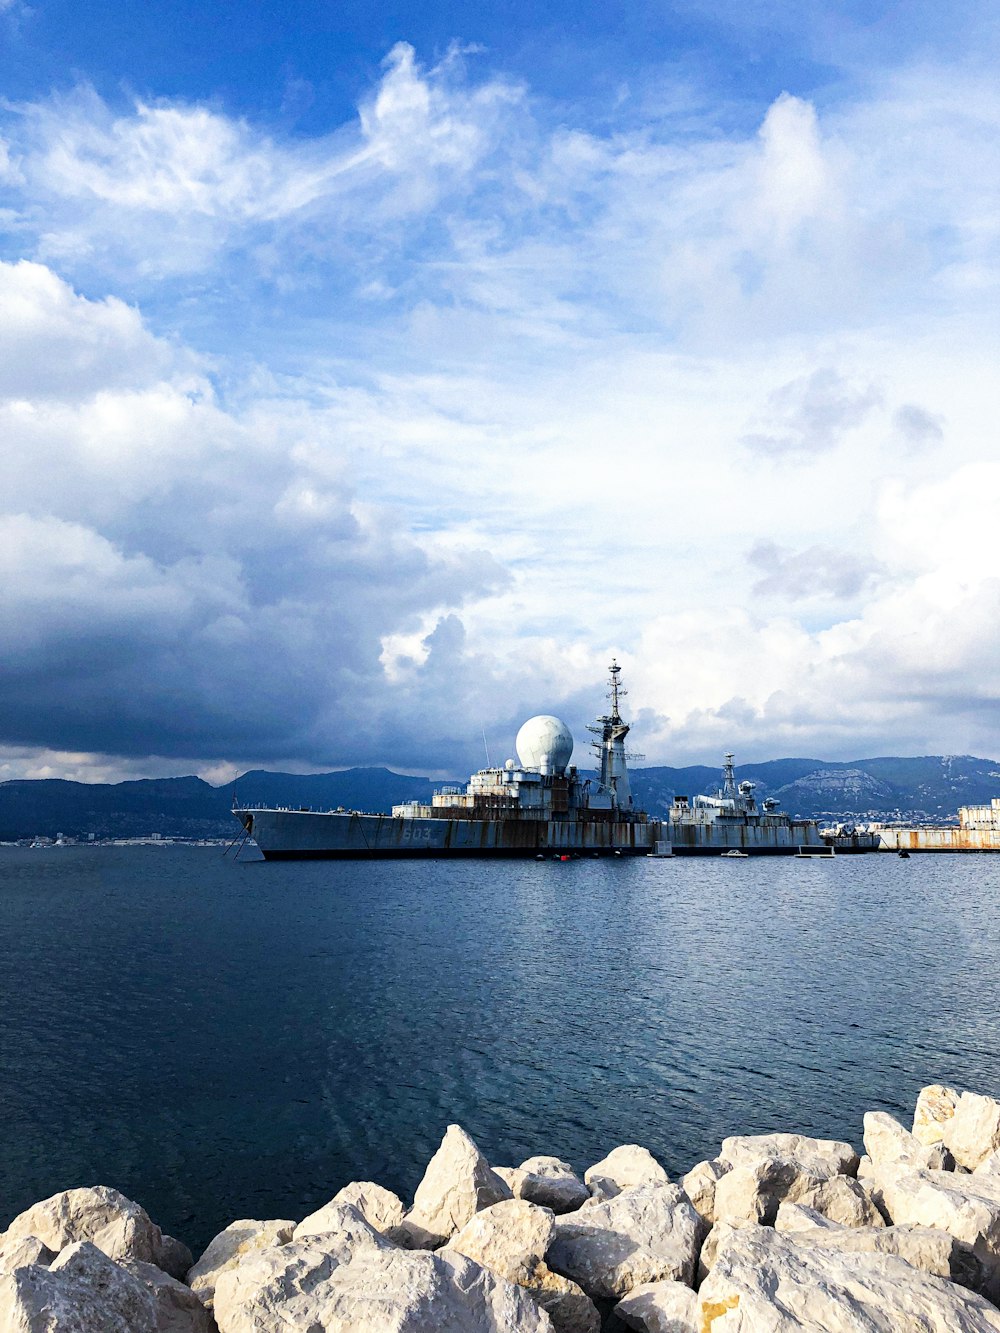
[0,1085,1000,1333]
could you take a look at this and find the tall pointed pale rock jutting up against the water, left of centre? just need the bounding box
[401,1125,513,1249]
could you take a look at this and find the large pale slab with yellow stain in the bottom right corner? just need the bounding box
[699,1226,1000,1333]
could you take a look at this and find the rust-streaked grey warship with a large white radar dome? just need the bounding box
[233,661,823,861]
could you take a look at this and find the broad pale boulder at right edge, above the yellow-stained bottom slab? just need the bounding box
[877,1165,1000,1300]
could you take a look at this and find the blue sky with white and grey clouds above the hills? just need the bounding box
[0,0,1000,781]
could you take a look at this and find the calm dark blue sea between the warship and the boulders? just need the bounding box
[0,846,1000,1252]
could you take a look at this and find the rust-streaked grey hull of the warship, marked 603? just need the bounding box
[241,809,823,861]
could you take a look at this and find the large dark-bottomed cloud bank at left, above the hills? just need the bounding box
[0,264,517,761]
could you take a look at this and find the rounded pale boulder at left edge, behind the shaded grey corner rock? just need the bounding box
[0,1185,184,1272]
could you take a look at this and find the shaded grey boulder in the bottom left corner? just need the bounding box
[0,1241,156,1333]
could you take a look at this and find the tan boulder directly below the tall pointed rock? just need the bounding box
[440,1198,600,1333]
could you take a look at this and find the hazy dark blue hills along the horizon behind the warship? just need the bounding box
[0,754,1000,841]
